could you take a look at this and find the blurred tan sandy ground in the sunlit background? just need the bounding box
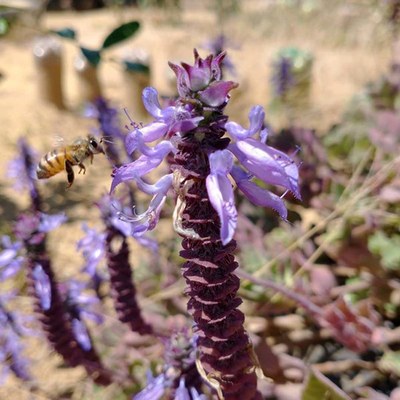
[0,0,391,399]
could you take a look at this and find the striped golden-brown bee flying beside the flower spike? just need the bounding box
[36,135,105,189]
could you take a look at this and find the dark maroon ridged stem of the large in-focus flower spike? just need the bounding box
[174,124,261,400]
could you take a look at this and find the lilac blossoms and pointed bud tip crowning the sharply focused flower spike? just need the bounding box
[111,51,300,245]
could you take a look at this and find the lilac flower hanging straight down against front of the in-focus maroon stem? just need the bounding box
[206,150,237,245]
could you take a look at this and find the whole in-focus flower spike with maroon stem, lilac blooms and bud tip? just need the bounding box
[111,51,300,400]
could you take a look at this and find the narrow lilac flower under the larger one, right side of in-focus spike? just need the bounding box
[231,167,287,220]
